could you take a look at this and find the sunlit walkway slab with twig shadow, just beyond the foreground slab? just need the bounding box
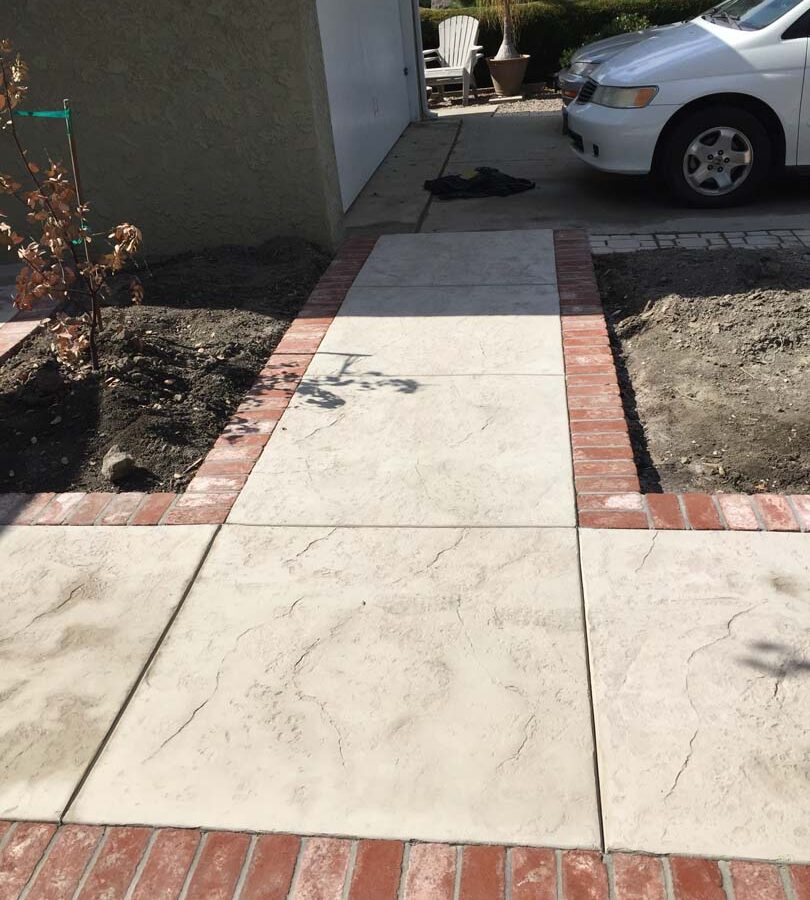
[224,375,575,526]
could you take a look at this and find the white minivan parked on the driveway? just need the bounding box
[567,0,810,207]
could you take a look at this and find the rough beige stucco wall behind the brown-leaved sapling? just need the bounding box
[0,0,342,253]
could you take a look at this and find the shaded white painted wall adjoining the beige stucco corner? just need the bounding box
[317,0,420,210]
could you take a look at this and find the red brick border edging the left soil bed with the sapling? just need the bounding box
[0,237,377,526]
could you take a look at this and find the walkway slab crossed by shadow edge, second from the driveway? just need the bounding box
[307,285,563,377]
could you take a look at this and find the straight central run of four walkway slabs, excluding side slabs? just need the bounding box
[69,232,600,847]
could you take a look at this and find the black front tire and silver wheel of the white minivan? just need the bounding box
[656,104,773,209]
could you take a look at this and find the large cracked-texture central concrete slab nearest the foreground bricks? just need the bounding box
[68,526,598,847]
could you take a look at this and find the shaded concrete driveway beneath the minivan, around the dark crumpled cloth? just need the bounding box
[347,106,810,234]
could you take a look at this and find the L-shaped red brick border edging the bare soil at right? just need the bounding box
[554,231,810,532]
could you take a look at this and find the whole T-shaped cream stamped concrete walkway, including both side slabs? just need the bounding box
[0,231,810,897]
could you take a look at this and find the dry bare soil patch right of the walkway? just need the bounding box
[596,250,810,493]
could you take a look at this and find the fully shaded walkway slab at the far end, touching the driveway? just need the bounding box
[355,230,557,287]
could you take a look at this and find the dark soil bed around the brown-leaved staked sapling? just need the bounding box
[0,239,329,492]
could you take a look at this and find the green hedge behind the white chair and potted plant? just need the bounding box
[422,0,711,84]
